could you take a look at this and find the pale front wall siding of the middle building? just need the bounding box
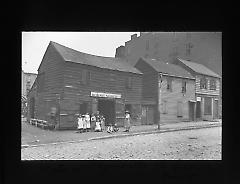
[160,77,195,123]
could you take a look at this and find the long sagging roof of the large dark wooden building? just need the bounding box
[50,41,142,74]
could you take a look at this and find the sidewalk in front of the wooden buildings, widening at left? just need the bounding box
[22,120,222,148]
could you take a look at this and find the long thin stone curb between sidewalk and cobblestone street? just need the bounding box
[21,123,222,149]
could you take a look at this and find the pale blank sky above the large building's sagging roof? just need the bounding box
[22,32,140,73]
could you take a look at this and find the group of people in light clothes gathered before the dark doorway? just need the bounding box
[77,111,131,133]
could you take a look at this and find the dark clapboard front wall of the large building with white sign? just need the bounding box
[60,62,142,129]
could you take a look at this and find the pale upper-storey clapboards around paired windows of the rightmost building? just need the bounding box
[196,75,220,95]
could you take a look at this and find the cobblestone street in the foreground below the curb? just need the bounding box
[21,127,222,160]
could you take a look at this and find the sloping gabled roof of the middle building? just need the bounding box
[141,58,194,79]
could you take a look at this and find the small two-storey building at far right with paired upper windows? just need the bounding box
[172,58,221,120]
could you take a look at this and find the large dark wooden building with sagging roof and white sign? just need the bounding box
[28,41,142,129]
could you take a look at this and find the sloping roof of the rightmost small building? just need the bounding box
[177,58,221,78]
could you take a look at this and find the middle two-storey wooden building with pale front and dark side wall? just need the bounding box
[135,58,195,123]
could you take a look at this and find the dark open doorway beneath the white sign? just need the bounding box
[98,99,115,125]
